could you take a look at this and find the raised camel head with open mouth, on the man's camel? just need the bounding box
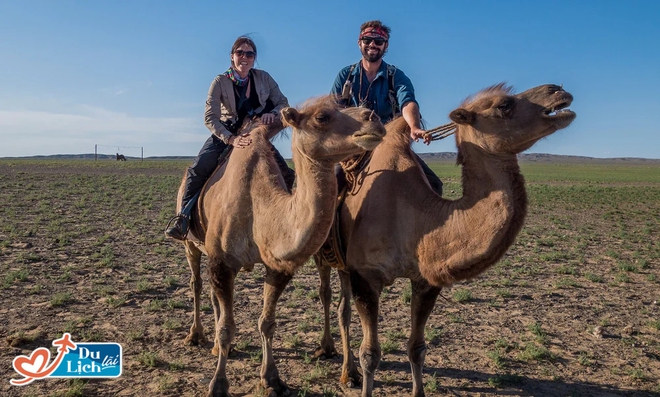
[449,84,575,154]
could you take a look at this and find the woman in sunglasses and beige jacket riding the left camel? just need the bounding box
[165,36,294,240]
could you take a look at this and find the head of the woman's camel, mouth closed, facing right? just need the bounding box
[282,97,385,163]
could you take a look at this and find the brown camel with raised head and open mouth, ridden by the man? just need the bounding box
[319,84,575,396]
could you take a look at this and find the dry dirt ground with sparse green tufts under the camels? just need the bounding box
[0,161,660,396]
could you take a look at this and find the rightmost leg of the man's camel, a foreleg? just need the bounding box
[408,279,440,397]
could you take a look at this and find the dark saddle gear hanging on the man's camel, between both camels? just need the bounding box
[315,151,373,270]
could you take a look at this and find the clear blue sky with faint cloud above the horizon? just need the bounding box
[0,0,660,158]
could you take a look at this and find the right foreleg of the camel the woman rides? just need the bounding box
[259,267,293,396]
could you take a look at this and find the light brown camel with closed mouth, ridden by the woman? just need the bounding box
[179,98,385,396]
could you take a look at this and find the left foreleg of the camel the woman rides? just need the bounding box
[208,258,236,397]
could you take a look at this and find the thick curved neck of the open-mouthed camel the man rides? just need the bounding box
[418,139,527,285]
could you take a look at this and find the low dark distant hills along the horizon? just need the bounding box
[0,152,660,165]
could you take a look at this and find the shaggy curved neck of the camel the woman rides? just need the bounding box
[262,138,337,271]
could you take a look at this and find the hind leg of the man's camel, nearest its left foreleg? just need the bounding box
[338,270,362,387]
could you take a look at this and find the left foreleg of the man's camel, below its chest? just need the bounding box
[351,272,382,397]
